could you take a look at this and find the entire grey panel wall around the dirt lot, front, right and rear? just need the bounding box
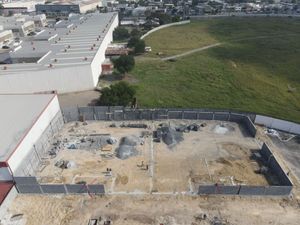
[15,106,292,196]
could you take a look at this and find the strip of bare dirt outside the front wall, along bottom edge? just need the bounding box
[1,194,300,225]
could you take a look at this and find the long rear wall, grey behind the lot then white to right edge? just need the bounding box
[62,106,300,135]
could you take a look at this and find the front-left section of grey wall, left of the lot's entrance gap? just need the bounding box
[14,177,105,194]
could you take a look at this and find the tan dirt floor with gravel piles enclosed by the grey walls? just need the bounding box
[37,120,277,194]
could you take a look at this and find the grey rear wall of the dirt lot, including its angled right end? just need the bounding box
[62,106,256,137]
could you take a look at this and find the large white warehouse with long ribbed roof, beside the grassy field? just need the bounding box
[0,13,118,93]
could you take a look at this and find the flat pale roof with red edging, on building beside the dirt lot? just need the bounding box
[0,94,56,162]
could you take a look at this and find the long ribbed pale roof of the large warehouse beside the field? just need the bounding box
[0,13,117,75]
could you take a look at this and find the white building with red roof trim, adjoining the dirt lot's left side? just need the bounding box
[0,93,63,215]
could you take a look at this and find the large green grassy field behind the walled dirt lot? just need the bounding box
[132,18,300,122]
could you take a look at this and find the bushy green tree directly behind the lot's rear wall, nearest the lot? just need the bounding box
[99,81,136,106]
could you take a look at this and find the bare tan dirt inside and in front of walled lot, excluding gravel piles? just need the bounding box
[1,120,300,225]
